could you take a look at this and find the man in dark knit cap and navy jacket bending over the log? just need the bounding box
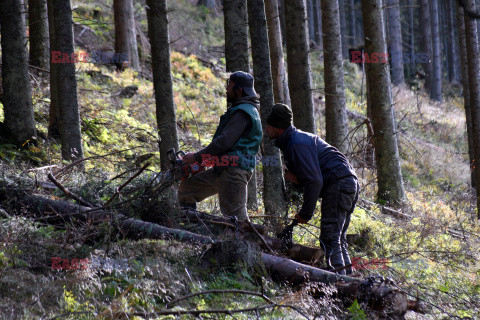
[266,104,358,274]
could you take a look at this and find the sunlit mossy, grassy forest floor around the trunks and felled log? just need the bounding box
[0,0,480,319]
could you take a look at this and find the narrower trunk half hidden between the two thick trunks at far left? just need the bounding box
[28,0,50,69]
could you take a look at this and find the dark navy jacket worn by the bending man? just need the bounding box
[275,126,356,220]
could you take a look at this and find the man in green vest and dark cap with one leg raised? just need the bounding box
[178,71,263,220]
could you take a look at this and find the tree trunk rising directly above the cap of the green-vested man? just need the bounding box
[223,0,249,72]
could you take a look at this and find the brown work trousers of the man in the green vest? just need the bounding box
[178,167,252,220]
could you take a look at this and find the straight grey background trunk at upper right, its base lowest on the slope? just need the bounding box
[429,0,442,101]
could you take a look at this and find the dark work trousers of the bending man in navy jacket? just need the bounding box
[320,176,359,274]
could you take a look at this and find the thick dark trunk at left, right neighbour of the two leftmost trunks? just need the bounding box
[48,0,83,160]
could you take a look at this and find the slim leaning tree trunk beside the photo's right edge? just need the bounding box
[457,6,475,187]
